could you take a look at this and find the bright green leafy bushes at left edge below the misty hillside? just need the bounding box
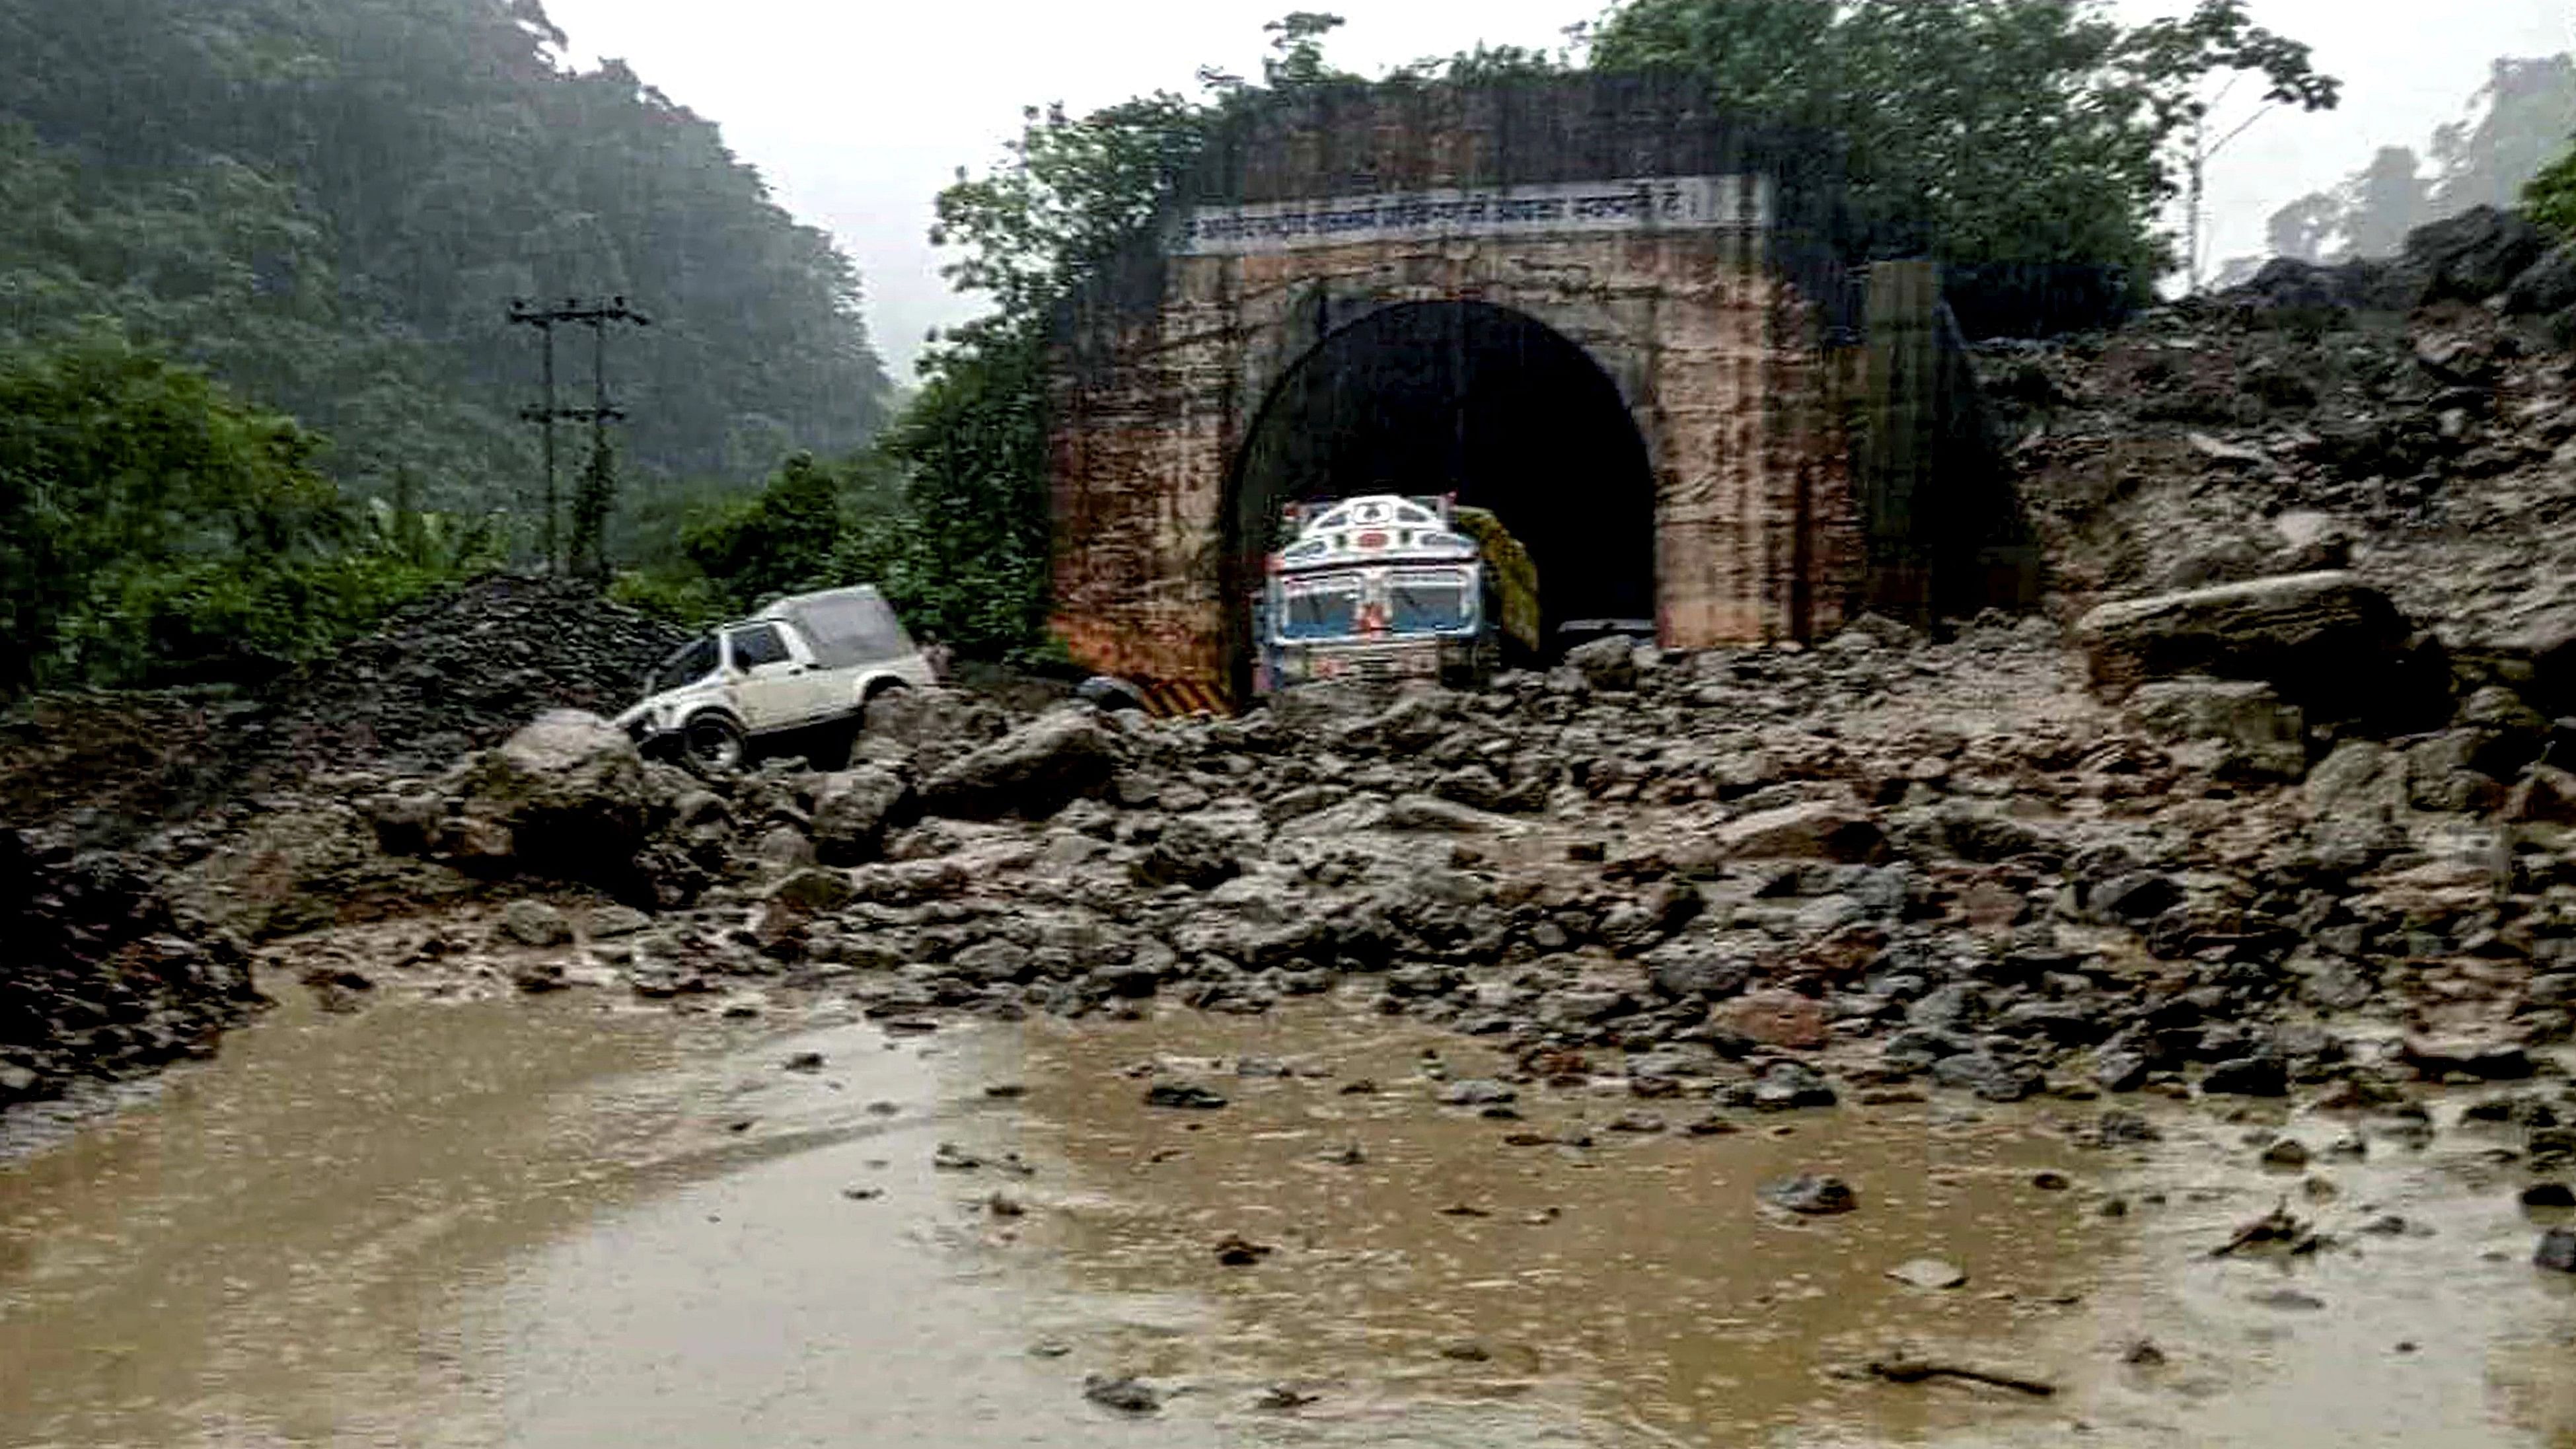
[0,335,495,694]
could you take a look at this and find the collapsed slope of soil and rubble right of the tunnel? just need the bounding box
[1978,209,2576,675]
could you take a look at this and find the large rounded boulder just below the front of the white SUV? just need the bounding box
[448,709,651,889]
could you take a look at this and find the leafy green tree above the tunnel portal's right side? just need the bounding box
[1592,0,2336,286]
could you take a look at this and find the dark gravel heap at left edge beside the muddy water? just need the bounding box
[0,830,260,1106]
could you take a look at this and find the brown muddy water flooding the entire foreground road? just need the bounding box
[0,992,2576,1449]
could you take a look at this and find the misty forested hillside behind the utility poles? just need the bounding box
[0,0,891,513]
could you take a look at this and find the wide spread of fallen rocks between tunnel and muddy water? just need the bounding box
[337,598,2576,1109]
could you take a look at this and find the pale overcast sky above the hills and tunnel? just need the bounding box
[546,0,2576,379]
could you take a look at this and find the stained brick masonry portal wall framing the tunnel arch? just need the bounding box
[1051,235,1860,683]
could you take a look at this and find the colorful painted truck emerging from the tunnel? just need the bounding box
[1252,492,1541,694]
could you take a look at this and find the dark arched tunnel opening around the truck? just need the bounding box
[1226,302,1656,696]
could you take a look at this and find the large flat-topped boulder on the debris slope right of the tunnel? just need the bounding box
[2077,570,2450,722]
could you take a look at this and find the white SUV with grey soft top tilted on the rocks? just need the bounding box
[618,585,938,771]
